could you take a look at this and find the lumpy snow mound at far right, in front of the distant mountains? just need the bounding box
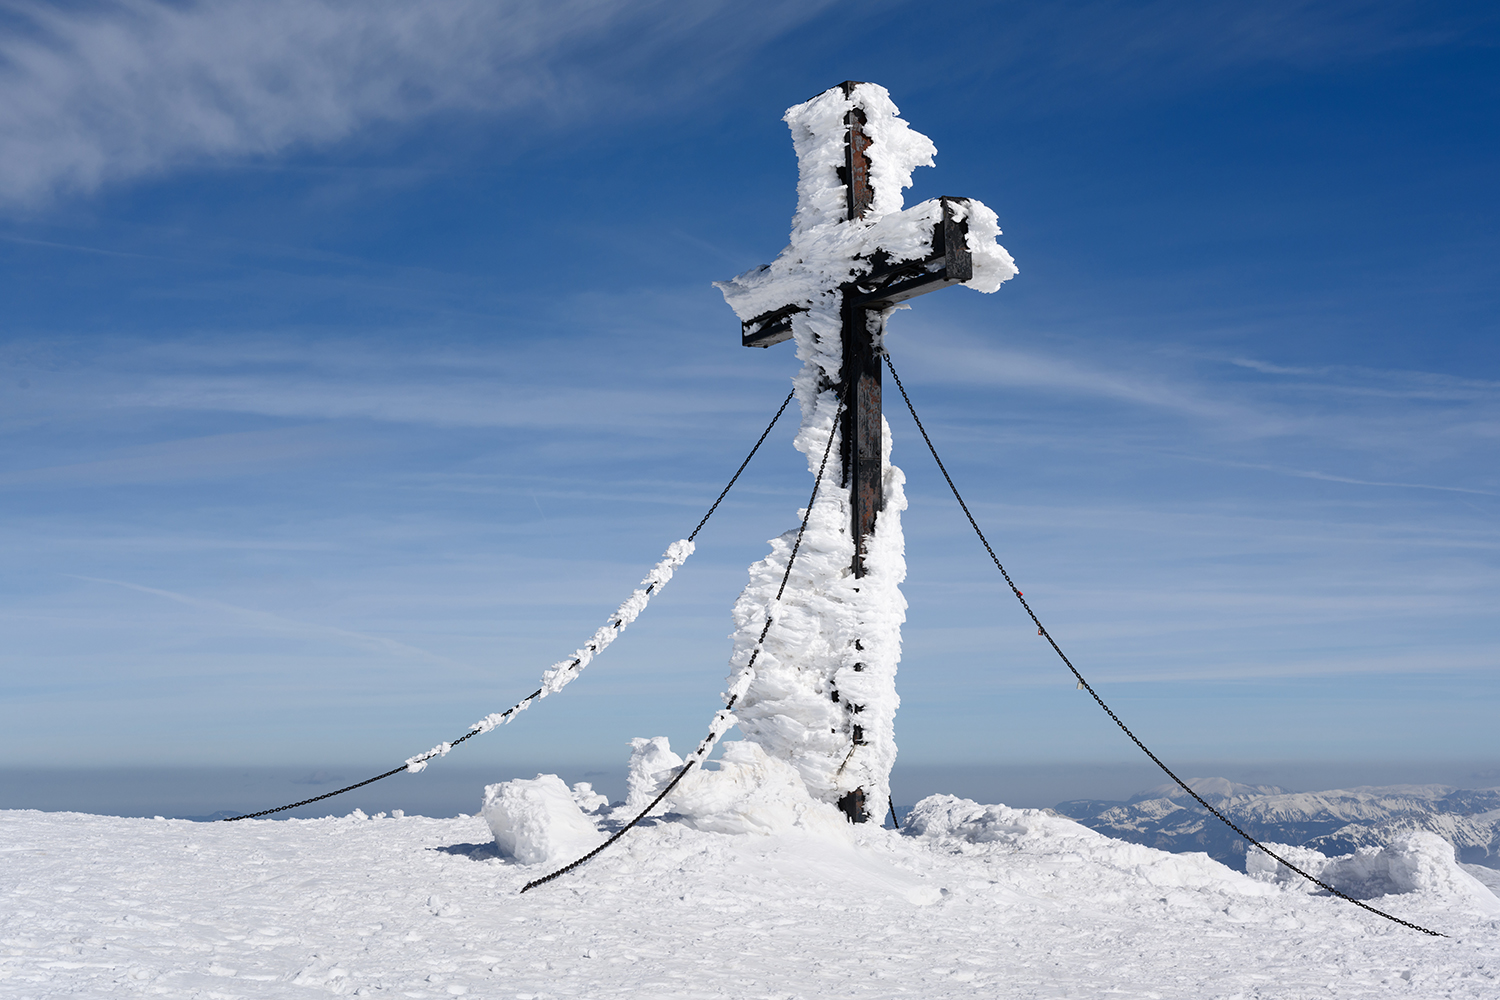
[1245,831,1500,915]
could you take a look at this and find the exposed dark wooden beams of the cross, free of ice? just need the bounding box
[741,81,974,577]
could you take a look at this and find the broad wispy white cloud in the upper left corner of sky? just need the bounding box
[0,0,827,205]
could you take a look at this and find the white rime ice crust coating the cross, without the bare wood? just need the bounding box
[719,84,1017,813]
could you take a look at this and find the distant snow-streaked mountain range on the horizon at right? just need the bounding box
[1055,778,1500,870]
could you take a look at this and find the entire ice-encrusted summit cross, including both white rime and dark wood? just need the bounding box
[717,82,1016,822]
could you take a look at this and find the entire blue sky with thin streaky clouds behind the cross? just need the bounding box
[0,0,1500,803]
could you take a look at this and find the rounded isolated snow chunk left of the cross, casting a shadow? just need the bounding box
[482,774,605,865]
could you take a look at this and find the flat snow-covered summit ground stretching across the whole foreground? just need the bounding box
[0,790,1500,1000]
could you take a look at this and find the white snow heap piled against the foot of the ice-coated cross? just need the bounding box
[668,741,852,843]
